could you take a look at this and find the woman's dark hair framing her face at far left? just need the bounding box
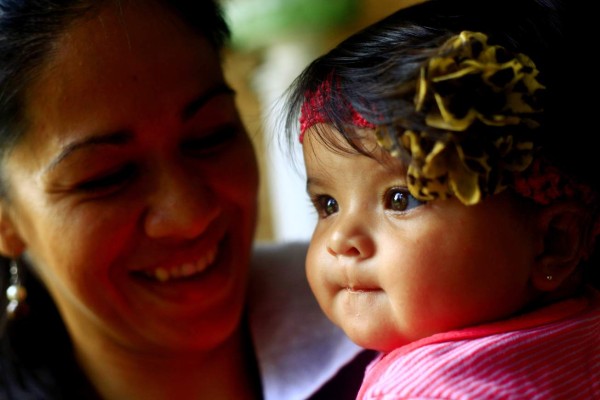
[0,0,230,399]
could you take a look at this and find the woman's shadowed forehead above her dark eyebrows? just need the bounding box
[19,2,224,156]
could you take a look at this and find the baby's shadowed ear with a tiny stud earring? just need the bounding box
[532,203,591,291]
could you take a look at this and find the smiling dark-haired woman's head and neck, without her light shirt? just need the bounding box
[0,0,368,399]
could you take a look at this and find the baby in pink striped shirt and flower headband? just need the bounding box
[286,0,600,399]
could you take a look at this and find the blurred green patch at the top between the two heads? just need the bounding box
[222,0,359,48]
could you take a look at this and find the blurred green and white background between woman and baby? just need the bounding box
[221,0,422,242]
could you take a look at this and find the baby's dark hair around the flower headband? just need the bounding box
[284,0,600,287]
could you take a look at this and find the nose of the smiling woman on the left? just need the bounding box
[144,167,221,239]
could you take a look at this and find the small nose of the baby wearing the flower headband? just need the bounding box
[327,214,375,259]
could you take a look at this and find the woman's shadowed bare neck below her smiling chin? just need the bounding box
[72,324,261,400]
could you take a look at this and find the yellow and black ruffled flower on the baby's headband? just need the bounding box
[377,31,544,205]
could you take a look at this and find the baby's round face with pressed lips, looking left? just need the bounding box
[303,127,536,351]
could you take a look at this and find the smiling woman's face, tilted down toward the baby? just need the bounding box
[3,2,258,349]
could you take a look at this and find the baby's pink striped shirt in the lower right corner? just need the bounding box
[358,289,600,400]
